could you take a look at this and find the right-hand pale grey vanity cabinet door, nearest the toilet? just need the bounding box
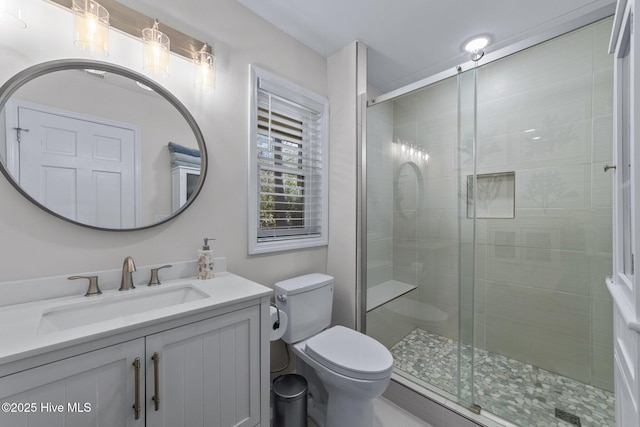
[146,306,260,427]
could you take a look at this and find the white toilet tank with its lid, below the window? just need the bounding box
[275,273,333,344]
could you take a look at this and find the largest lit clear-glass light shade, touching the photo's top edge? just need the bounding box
[71,0,109,56]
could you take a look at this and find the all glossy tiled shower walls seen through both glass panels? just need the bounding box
[367,15,613,398]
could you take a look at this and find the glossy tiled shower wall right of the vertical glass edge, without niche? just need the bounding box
[475,20,613,391]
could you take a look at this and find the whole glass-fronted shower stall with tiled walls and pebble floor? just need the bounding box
[363,19,615,426]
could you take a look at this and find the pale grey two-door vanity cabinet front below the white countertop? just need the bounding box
[0,300,269,427]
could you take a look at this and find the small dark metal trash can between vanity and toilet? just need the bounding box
[273,374,307,427]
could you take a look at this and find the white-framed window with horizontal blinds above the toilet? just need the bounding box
[248,66,329,254]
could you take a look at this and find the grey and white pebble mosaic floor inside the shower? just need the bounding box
[391,329,615,427]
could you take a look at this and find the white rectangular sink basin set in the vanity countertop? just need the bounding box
[37,285,209,335]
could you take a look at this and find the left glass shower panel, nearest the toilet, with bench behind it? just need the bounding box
[366,73,474,407]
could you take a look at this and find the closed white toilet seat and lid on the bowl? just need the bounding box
[305,326,393,380]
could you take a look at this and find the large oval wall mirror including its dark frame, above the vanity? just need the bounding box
[0,60,207,230]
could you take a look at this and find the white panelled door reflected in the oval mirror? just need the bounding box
[5,100,140,228]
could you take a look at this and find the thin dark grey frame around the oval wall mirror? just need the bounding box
[0,59,208,231]
